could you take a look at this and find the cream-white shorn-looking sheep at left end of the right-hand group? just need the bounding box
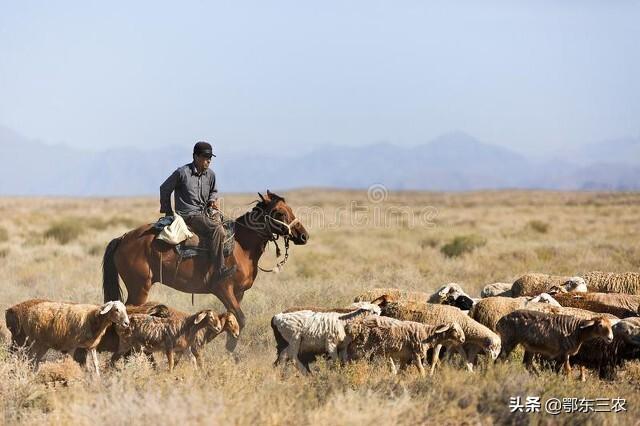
[271,305,380,374]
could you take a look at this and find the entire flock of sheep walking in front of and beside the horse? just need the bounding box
[3,272,640,380]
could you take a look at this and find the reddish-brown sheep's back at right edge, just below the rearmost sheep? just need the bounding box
[555,293,640,318]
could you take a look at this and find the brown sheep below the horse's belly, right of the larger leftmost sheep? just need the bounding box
[116,309,222,371]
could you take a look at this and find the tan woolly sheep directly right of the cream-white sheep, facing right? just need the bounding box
[345,316,465,376]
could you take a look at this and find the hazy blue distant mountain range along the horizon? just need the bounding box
[0,127,640,196]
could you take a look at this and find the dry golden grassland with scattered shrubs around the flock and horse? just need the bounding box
[0,190,640,425]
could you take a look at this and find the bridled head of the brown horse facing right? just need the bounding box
[256,189,309,245]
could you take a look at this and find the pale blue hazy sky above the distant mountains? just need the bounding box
[0,0,640,152]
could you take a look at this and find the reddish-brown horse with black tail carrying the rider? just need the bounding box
[102,190,309,351]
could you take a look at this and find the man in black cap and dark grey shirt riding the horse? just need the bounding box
[160,141,235,285]
